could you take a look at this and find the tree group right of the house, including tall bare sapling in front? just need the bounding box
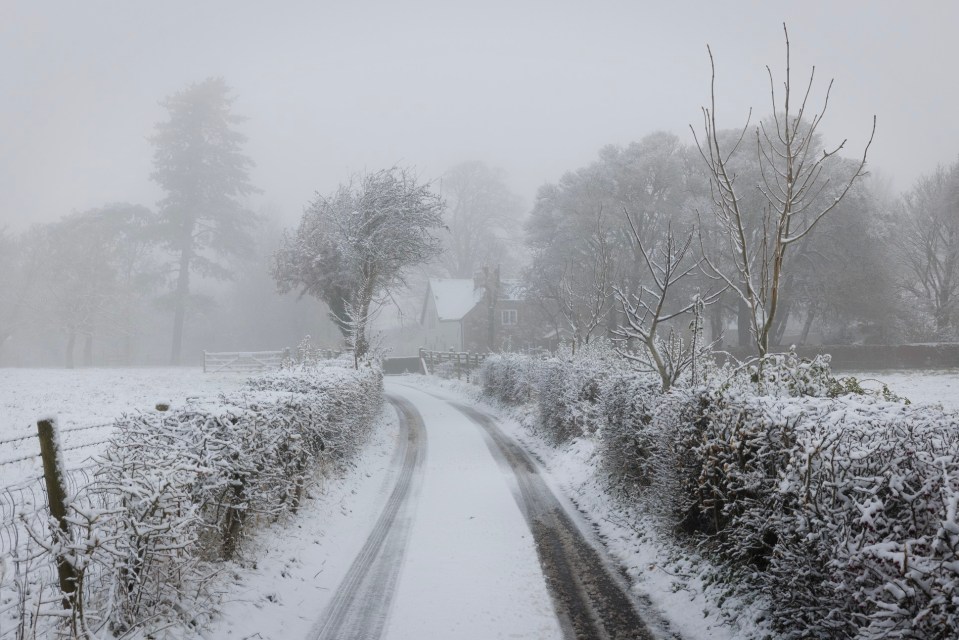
[523,30,959,359]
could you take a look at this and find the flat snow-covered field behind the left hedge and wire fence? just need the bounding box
[0,367,249,487]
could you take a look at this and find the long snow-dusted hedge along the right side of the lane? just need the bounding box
[484,351,959,639]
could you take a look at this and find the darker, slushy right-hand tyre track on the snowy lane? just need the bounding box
[452,396,671,640]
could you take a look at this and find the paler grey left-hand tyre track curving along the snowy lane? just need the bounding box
[307,395,426,640]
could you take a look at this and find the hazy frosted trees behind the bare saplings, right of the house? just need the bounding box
[524,131,959,348]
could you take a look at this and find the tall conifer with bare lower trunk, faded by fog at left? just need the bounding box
[150,78,256,365]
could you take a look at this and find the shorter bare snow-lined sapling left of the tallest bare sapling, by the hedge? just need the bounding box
[614,212,722,392]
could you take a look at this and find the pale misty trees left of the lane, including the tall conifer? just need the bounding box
[0,78,338,367]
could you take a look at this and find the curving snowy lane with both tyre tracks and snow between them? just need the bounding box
[309,381,652,640]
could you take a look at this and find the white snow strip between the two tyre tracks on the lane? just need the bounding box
[385,379,563,640]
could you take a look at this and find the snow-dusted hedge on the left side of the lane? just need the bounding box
[57,363,383,635]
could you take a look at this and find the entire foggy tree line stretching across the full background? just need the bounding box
[0,34,959,370]
